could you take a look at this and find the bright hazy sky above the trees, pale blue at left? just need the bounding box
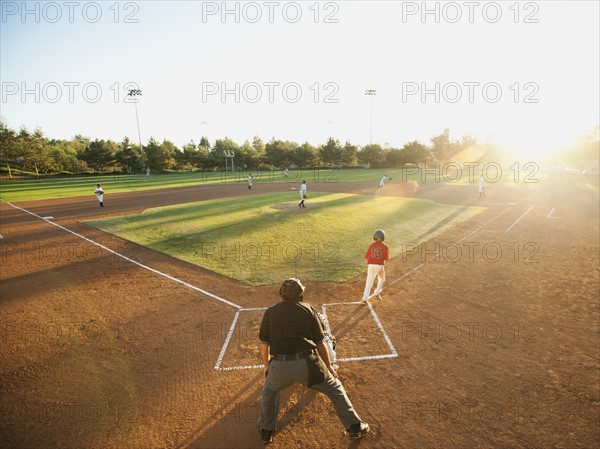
[0,1,600,157]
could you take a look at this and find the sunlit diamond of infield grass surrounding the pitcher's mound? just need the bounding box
[86,191,483,285]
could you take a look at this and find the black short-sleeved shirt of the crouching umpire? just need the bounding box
[258,301,325,355]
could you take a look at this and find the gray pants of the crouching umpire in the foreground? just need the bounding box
[258,359,360,430]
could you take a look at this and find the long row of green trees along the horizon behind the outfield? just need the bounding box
[0,121,596,175]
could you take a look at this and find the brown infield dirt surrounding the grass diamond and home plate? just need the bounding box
[0,182,600,449]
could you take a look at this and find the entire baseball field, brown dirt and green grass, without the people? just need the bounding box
[0,170,600,449]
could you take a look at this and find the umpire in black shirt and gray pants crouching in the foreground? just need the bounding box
[258,278,369,444]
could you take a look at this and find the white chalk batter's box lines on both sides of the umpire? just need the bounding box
[214,301,398,371]
